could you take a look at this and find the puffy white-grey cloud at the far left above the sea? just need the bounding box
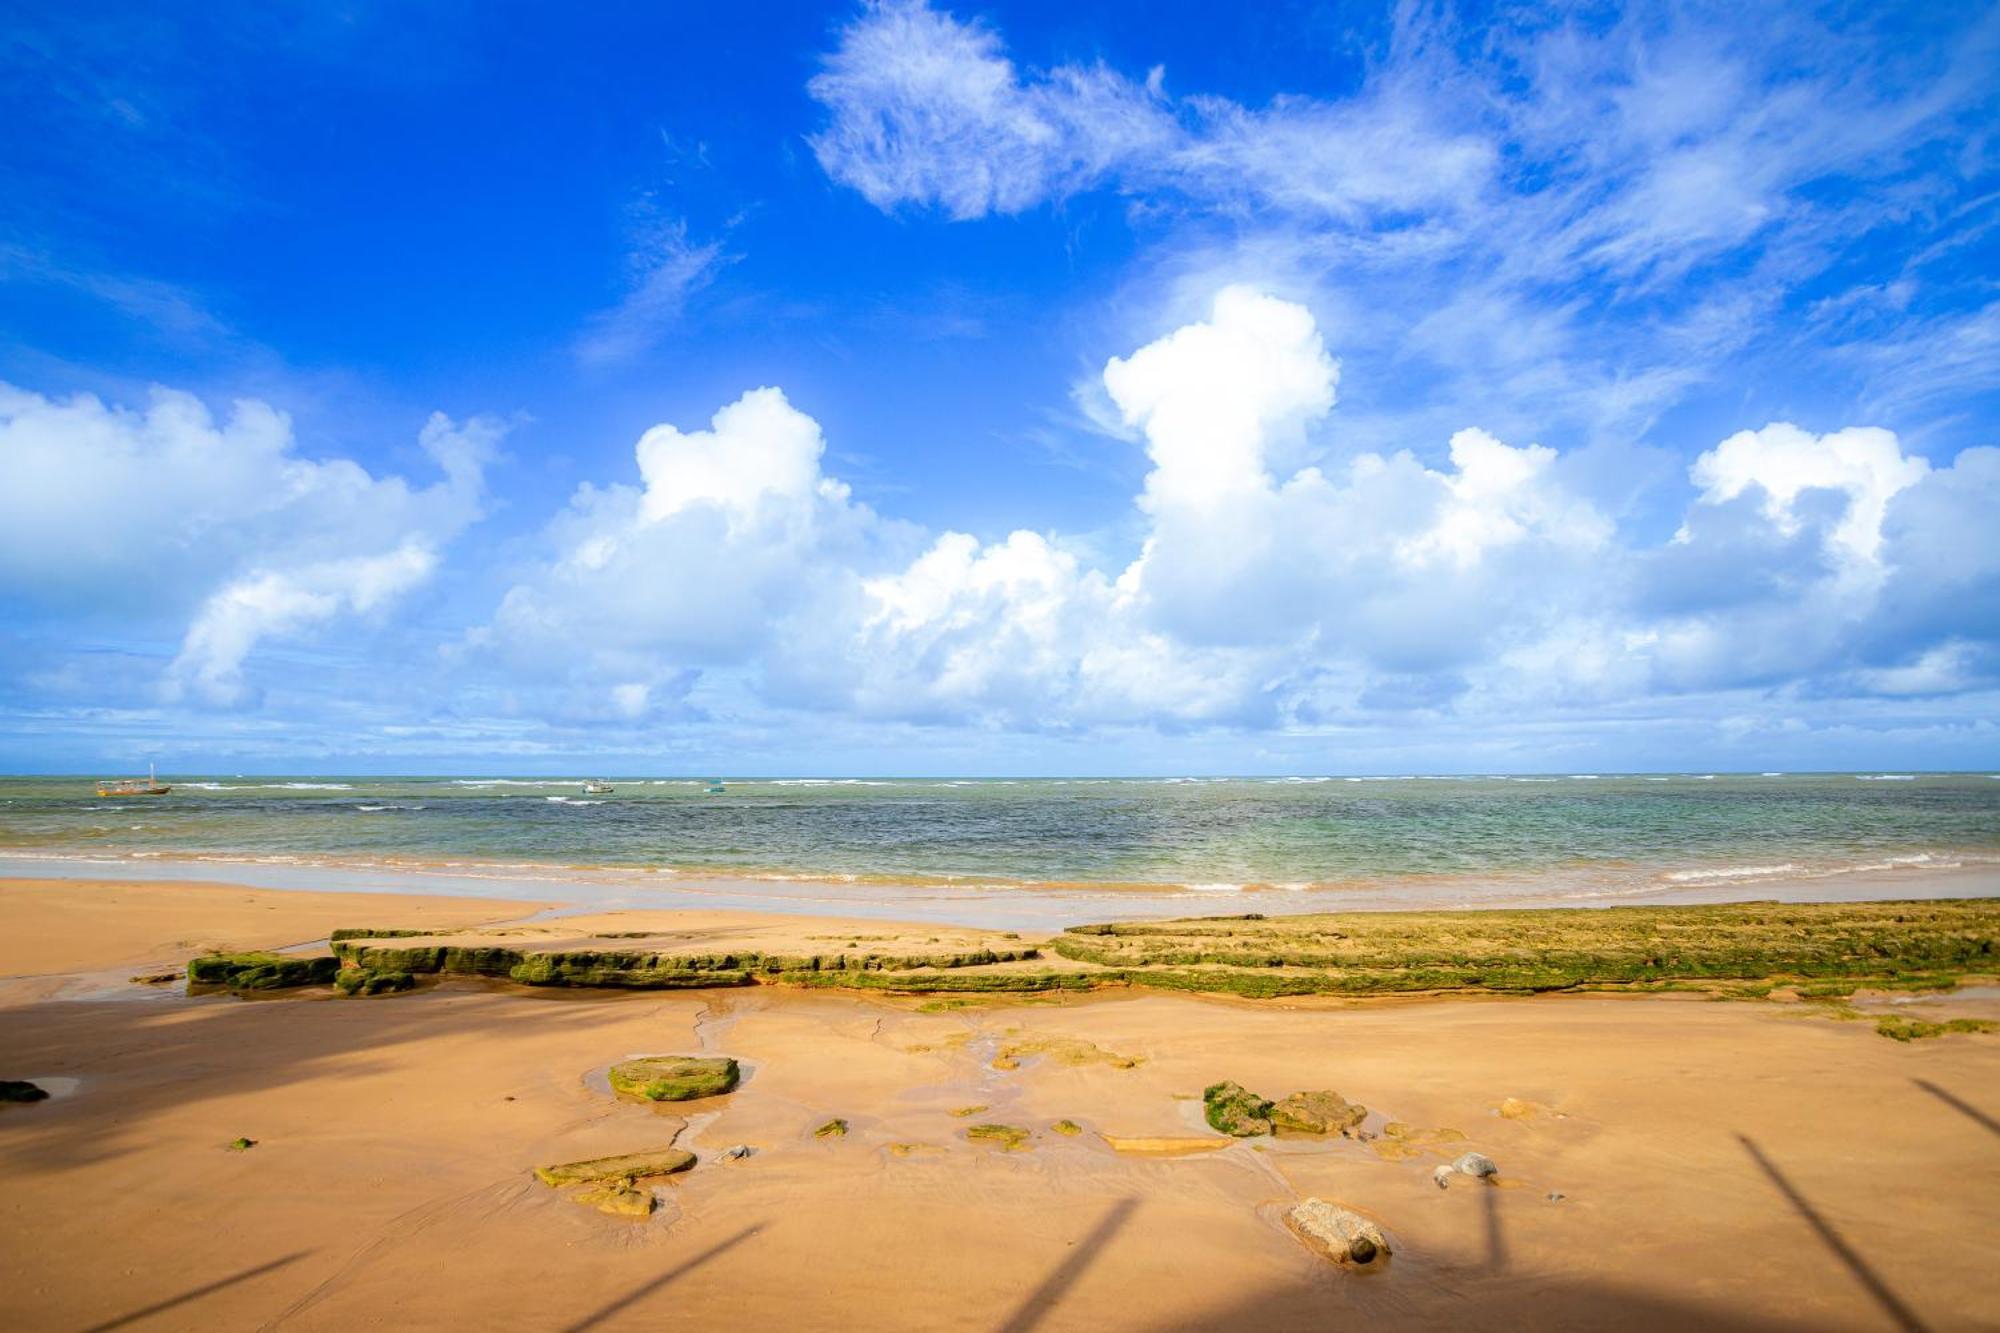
[0,384,502,705]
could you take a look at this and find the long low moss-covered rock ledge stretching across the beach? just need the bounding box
[238,899,2000,996]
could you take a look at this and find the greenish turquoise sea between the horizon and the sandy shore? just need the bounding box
[0,773,2000,899]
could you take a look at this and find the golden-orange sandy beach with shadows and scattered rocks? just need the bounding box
[0,883,2000,1329]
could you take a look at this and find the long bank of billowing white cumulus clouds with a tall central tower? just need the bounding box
[488,286,2000,733]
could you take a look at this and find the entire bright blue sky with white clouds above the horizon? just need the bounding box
[0,0,2000,775]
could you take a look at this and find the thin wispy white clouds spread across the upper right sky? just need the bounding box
[808,0,2000,456]
